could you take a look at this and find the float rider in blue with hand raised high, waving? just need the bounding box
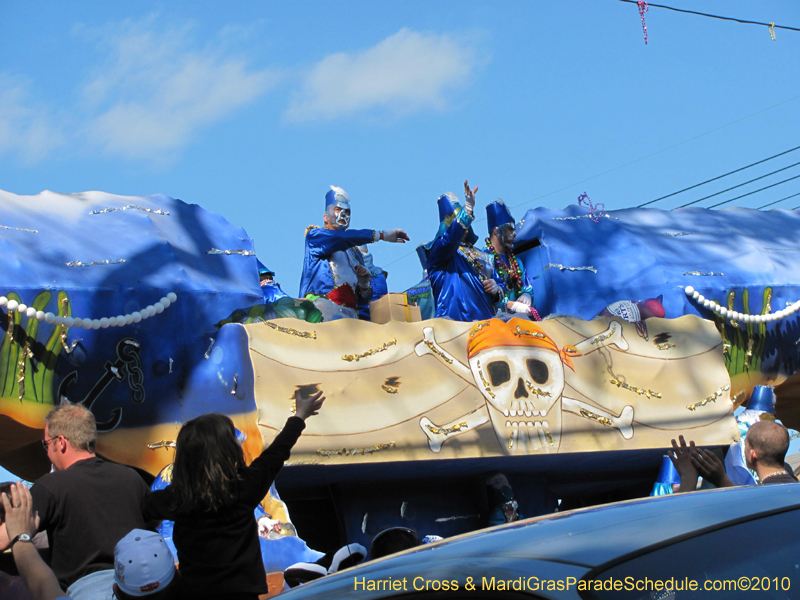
[427,181,503,321]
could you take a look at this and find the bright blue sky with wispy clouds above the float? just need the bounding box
[0,0,800,293]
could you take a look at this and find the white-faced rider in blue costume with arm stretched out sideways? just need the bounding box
[300,186,409,321]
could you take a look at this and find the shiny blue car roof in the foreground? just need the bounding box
[284,484,800,592]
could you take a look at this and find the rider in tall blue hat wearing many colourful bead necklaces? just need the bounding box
[486,200,533,316]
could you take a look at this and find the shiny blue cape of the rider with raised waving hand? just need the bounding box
[428,211,503,321]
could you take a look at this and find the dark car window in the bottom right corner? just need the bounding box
[581,510,800,600]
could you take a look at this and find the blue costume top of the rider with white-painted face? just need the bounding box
[300,228,374,308]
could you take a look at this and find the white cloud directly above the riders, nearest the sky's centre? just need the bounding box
[286,28,477,121]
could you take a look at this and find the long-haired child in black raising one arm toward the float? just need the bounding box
[143,391,325,600]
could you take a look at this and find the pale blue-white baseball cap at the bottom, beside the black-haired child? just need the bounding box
[114,529,175,596]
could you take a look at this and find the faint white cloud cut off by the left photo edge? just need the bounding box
[0,74,64,163]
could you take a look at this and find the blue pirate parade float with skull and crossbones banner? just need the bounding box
[0,192,800,564]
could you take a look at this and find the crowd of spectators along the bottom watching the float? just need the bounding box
[0,392,797,600]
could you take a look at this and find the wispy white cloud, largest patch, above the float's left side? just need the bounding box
[82,20,278,161]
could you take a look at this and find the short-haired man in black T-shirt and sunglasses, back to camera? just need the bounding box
[0,403,149,600]
